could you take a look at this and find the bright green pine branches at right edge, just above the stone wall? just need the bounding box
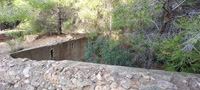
[157,16,200,73]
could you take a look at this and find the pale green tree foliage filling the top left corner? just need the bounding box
[0,0,33,27]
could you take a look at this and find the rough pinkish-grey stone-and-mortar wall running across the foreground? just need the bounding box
[0,54,200,90]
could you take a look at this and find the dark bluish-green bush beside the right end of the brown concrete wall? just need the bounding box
[84,38,135,66]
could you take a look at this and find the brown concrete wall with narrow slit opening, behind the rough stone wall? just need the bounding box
[11,37,87,60]
